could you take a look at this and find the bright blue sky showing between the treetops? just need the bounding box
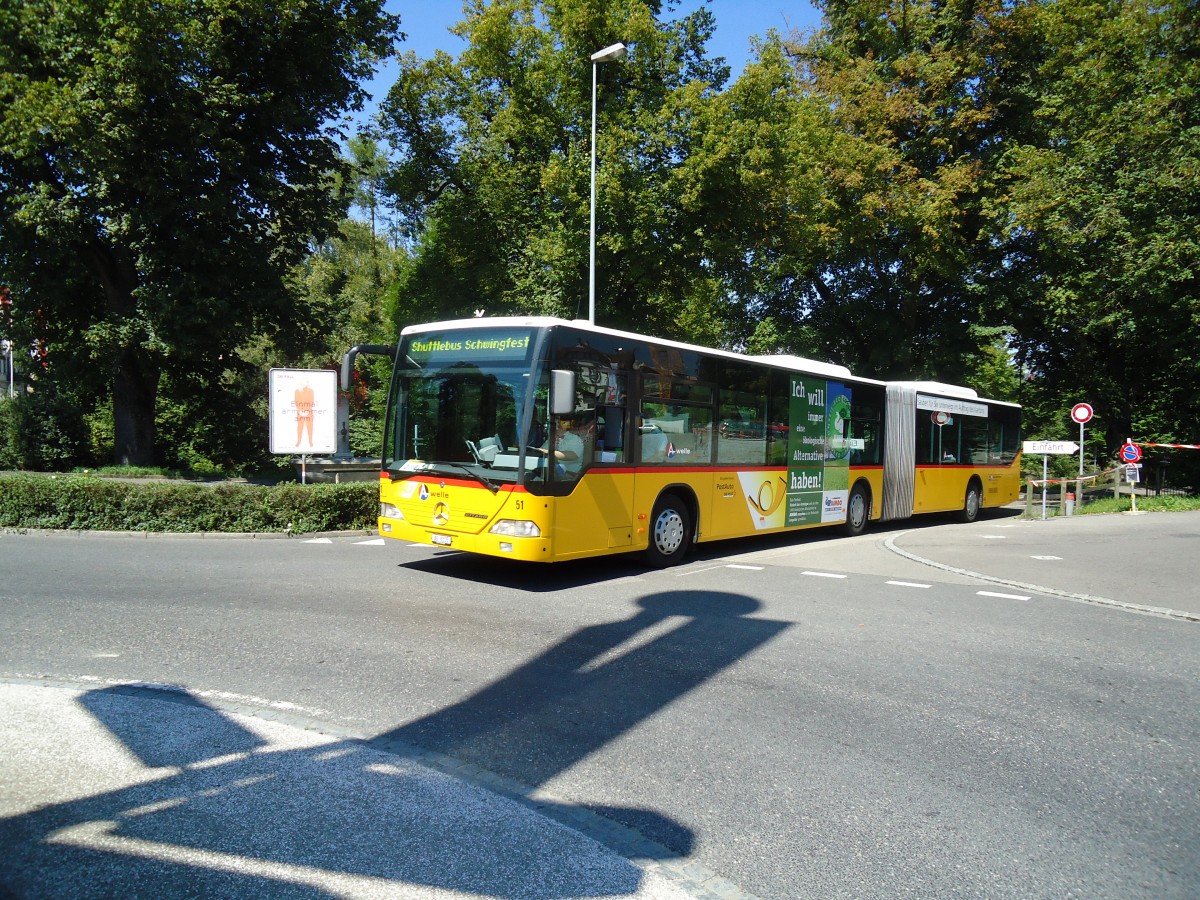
[360,0,821,115]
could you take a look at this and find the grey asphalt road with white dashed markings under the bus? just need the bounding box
[0,514,1200,898]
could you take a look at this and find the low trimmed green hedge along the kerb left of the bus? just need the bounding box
[0,475,379,534]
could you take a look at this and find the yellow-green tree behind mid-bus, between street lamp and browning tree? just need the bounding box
[673,34,857,358]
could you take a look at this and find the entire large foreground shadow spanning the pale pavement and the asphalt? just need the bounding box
[0,592,787,899]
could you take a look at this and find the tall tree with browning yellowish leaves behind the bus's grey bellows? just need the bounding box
[775,0,1027,382]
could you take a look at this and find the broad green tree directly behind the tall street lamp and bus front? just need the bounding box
[379,0,727,334]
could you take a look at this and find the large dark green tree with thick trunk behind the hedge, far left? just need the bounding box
[0,0,398,463]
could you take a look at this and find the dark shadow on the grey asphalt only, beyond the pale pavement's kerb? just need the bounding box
[371,590,788,854]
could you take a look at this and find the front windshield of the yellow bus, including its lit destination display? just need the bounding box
[384,329,544,491]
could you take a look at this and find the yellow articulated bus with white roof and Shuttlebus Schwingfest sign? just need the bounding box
[379,318,1021,566]
